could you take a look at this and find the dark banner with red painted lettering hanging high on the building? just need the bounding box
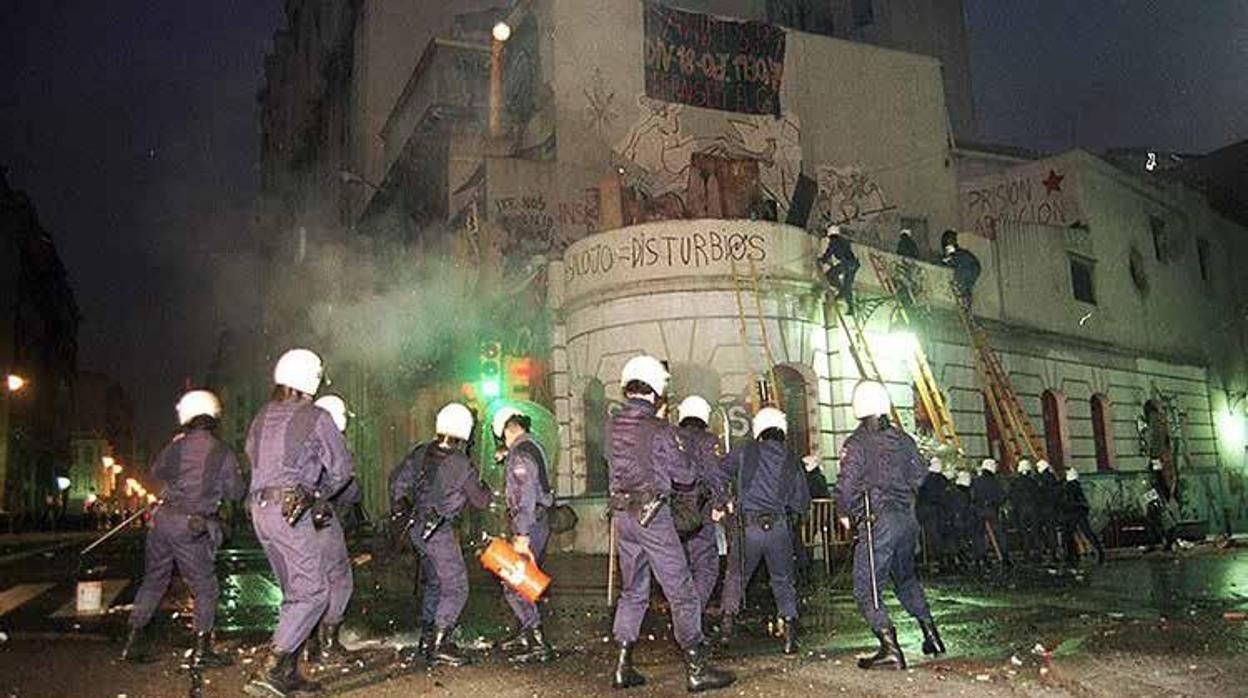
[645,1,785,116]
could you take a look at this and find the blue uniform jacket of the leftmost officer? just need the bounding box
[151,430,245,516]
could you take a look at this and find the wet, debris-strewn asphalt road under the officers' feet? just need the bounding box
[0,536,1248,697]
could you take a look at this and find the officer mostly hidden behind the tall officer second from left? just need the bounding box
[303,395,361,666]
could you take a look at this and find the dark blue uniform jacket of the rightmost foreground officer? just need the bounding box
[836,425,927,516]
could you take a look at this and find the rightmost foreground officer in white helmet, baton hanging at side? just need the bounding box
[836,381,945,669]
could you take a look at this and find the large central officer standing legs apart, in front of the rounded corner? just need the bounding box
[607,356,736,692]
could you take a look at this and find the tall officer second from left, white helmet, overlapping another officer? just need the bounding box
[243,348,354,697]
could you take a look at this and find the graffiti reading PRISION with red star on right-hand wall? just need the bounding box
[961,162,1083,238]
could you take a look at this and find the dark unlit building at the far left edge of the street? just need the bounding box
[0,172,79,524]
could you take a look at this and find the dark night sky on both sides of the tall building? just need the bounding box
[0,0,1248,449]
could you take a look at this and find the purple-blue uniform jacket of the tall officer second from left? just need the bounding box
[247,400,354,493]
